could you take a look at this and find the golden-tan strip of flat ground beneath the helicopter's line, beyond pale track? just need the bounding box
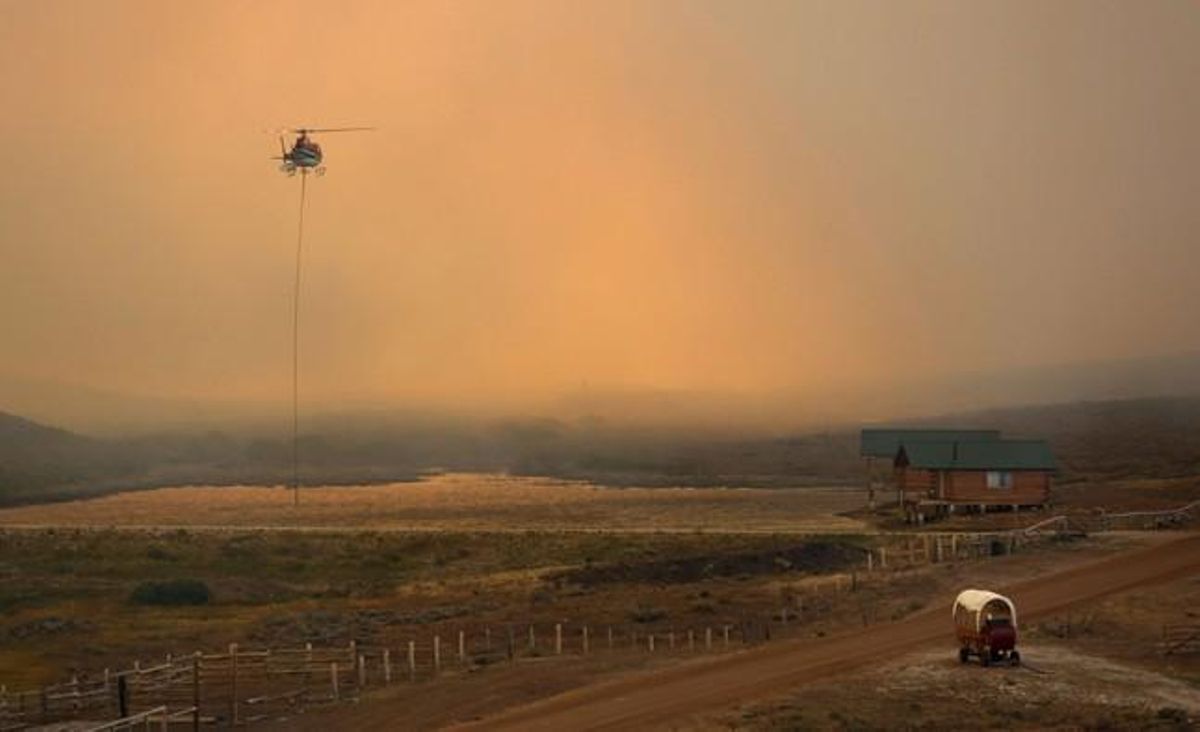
[0,474,865,533]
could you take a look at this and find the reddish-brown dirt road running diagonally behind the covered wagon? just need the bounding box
[460,535,1200,730]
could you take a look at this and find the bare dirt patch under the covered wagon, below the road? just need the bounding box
[729,643,1200,731]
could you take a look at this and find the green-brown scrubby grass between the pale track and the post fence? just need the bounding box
[0,529,883,688]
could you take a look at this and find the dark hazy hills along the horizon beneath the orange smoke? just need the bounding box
[0,397,1200,504]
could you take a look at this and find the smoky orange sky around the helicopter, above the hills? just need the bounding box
[0,0,1200,422]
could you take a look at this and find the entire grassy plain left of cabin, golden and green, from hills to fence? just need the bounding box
[0,474,863,685]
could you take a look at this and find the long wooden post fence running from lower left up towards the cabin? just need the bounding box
[0,532,1099,732]
